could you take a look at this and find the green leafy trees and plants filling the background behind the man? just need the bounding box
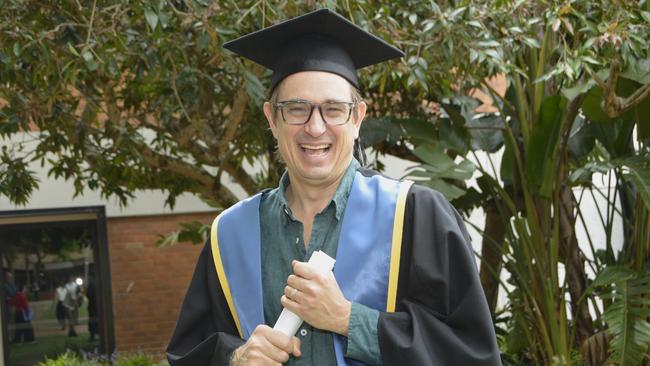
[0,0,650,365]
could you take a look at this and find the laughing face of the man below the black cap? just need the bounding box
[264,71,366,186]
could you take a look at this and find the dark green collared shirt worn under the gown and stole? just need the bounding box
[260,159,381,366]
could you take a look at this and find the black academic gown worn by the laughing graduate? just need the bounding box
[167,182,501,366]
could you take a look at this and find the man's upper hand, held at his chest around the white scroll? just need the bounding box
[280,261,352,336]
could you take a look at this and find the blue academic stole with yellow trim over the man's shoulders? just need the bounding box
[211,171,412,365]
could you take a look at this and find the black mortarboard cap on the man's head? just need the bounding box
[223,9,404,90]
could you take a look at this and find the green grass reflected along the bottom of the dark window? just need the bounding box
[9,334,99,366]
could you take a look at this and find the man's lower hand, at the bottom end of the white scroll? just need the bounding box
[230,325,300,366]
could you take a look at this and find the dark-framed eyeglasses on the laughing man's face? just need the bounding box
[273,100,357,126]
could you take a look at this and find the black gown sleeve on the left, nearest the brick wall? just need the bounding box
[167,240,244,366]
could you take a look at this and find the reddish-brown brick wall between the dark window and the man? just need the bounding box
[107,214,214,353]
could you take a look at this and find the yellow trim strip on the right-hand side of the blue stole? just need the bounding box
[386,181,413,313]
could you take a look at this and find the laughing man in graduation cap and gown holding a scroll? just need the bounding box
[167,10,500,365]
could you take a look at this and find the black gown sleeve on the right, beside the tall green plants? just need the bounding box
[378,185,501,366]
